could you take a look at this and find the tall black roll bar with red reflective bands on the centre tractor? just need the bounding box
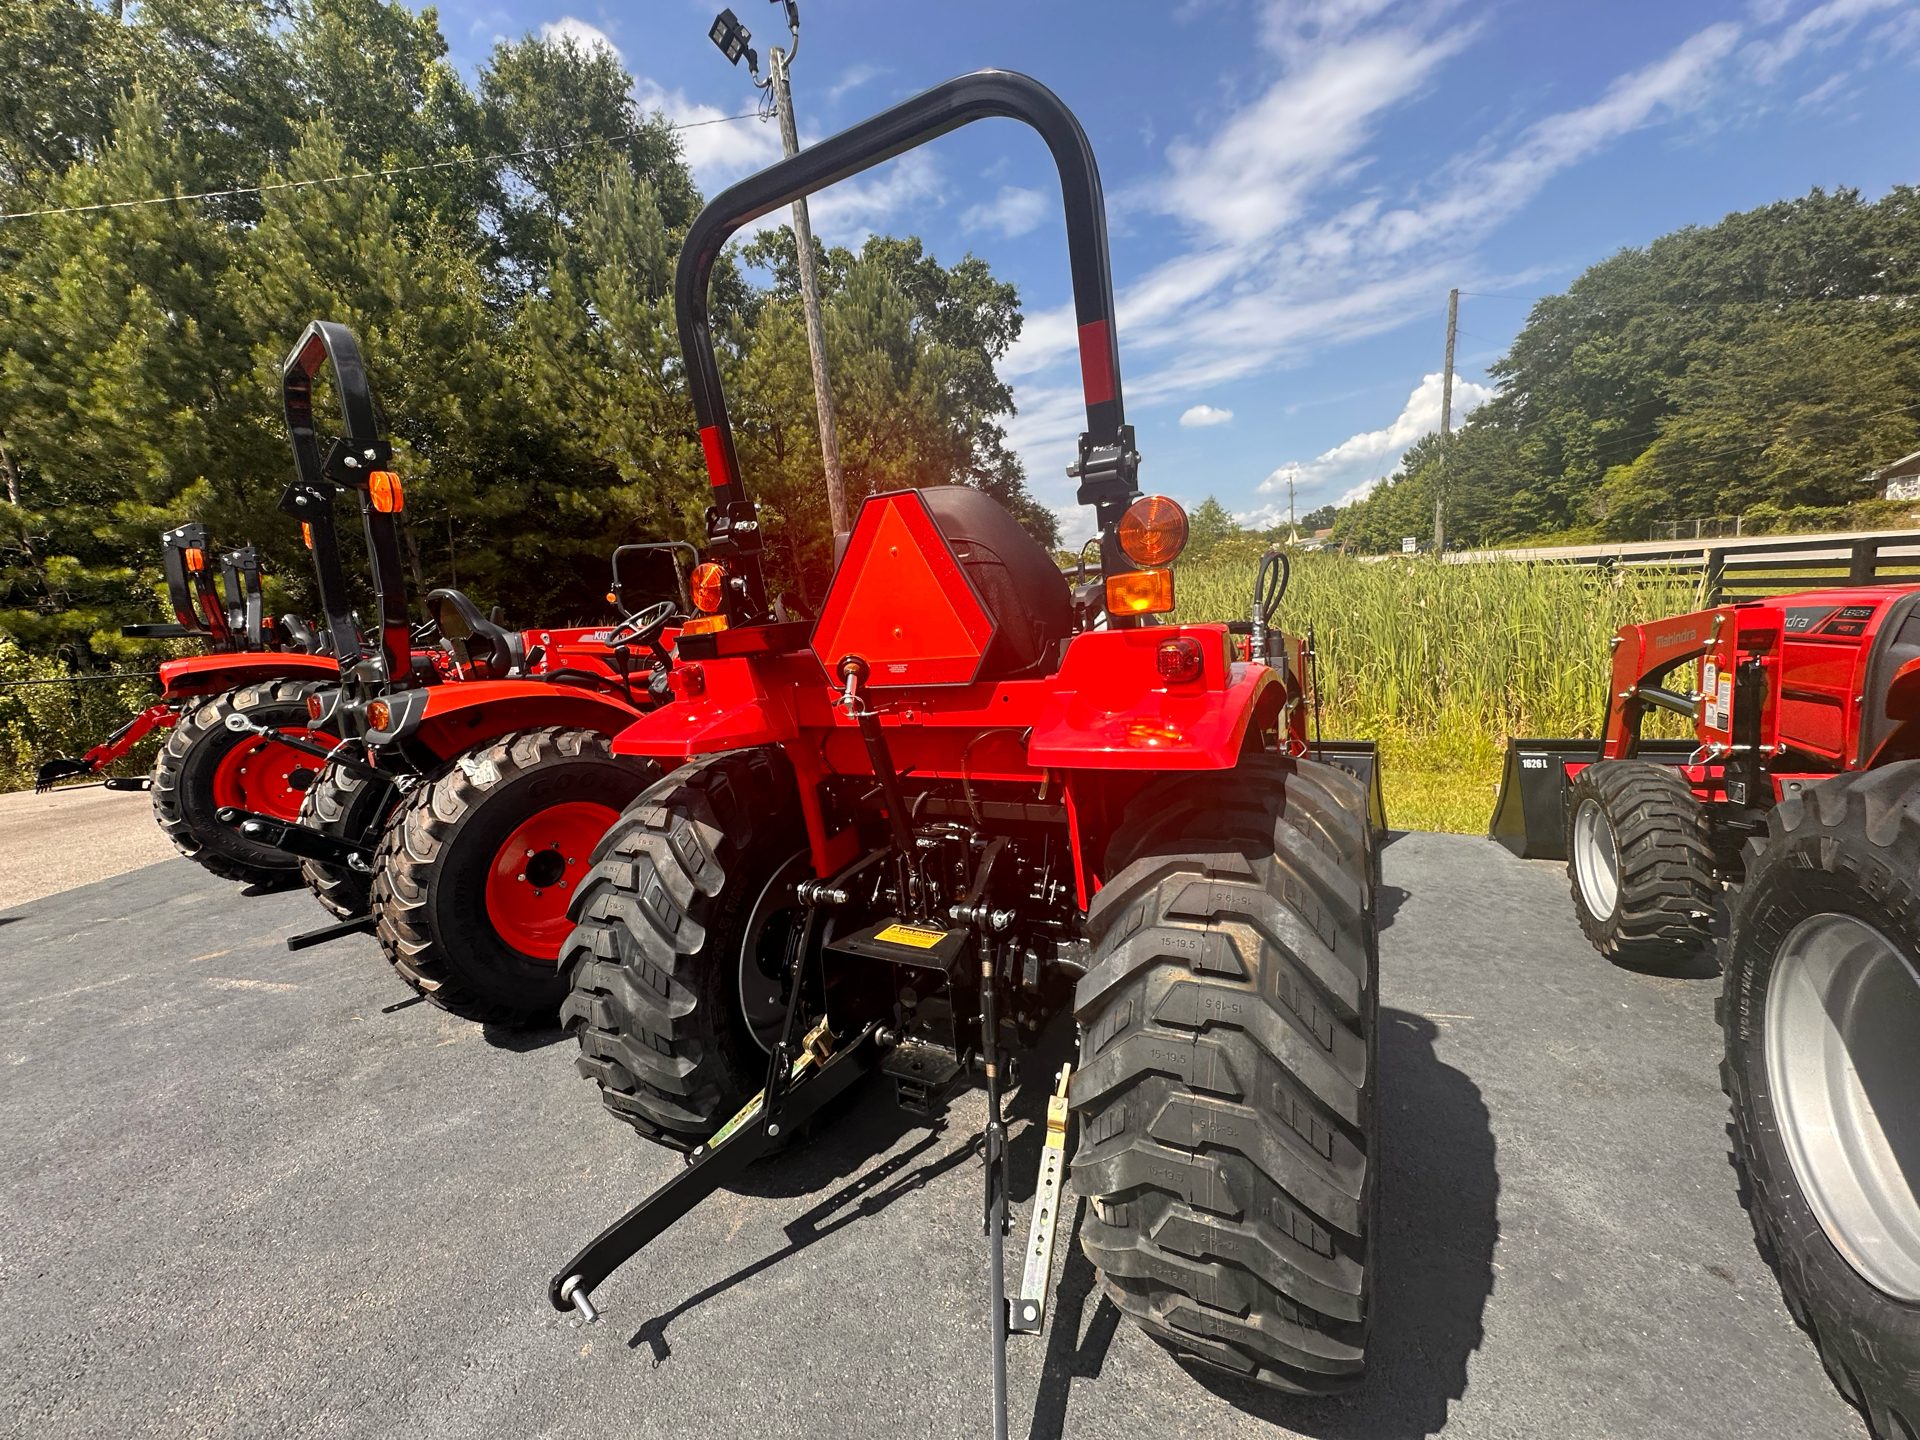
[674,69,1137,616]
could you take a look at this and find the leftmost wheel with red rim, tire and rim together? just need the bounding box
[152,680,330,885]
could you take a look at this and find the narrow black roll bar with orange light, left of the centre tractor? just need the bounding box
[280,321,413,685]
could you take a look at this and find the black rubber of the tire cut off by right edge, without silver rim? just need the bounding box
[1718,760,1920,1440]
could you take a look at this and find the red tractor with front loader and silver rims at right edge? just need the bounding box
[1492,586,1920,1438]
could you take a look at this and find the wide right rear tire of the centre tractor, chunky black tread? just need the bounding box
[1073,755,1379,1394]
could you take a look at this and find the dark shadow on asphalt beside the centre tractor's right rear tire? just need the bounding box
[1152,1008,1500,1440]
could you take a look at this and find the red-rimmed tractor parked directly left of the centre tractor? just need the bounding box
[223,321,678,1025]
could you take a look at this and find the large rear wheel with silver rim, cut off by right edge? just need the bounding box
[1720,760,1920,1440]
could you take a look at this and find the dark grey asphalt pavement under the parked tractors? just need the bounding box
[0,833,1864,1440]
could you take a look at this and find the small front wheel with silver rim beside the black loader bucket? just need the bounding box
[1567,760,1720,966]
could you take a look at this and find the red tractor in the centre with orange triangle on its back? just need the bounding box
[549,71,1382,1434]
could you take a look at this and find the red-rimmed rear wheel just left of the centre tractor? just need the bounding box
[372,726,660,1029]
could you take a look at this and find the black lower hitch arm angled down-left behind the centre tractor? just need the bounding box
[547,1021,879,1325]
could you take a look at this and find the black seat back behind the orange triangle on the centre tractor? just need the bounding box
[920,486,1073,680]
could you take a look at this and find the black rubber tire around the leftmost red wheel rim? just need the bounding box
[152,680,326,885]
